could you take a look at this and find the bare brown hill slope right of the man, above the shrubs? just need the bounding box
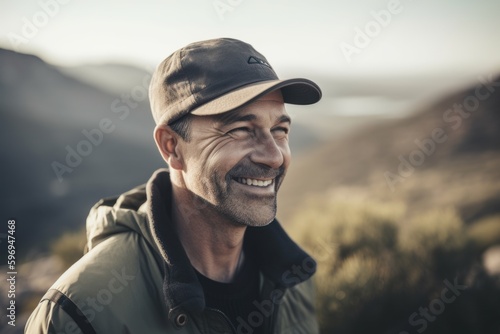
[279,73,500,222]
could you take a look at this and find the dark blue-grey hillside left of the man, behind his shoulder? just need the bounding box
[0,50,163,261]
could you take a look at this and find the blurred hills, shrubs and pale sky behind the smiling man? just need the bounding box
[0,0,500,334]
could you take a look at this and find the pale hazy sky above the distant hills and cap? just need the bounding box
[0,0,500,75]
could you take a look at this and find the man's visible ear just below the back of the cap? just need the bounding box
[154,124,183,170]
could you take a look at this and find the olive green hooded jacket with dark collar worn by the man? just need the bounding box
[25,170,318,334]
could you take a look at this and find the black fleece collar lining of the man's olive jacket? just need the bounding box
[146,169,316,319]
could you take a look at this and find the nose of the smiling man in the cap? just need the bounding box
[250,132,284,169]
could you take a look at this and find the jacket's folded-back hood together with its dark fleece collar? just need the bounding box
[86,169,316,319]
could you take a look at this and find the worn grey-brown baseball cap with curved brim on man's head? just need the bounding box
[149,38,321,124]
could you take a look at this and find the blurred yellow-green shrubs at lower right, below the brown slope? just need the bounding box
[290,198,500,334]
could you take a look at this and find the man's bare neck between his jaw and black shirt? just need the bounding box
[172,191,246,283]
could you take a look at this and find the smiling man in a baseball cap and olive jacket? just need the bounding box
[26,39,321,334]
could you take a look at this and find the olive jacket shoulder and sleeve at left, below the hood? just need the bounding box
[26,231,166,333]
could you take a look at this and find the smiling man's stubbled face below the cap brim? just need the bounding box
[179,91,290,226]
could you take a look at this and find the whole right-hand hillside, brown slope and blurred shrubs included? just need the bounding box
[278,74,500,334]
